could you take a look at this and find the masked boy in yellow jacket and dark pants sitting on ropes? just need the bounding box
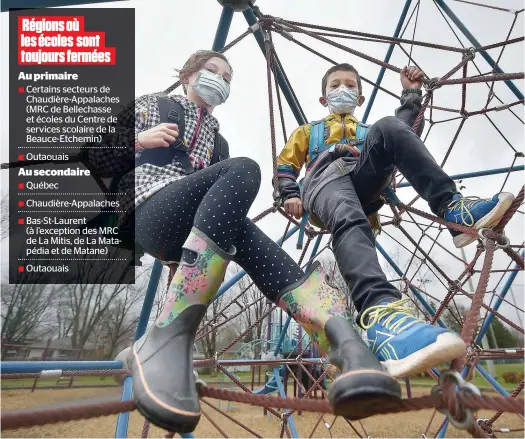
[277,64,514,377]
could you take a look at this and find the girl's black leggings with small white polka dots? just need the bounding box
[135,158,303,301]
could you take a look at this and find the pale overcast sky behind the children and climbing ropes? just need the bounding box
[2,0,524,328]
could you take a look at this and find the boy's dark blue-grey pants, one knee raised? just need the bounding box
[311,116,457,324]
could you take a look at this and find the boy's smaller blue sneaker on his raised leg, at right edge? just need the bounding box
[444,192,514,248]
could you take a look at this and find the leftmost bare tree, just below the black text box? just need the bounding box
[1,277,63,344]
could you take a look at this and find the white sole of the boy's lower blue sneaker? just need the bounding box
[381,332,467,378]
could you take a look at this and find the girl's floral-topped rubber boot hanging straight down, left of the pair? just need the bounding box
[128,229,235,433]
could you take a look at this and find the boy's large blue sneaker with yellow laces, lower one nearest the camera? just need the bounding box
[361,299,466,378]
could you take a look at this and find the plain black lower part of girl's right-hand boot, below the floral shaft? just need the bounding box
[325,317,401,420]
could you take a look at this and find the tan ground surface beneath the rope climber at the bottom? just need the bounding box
[1,388,523,438]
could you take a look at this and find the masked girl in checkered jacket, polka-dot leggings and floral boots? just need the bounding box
[83,51,401,433]
